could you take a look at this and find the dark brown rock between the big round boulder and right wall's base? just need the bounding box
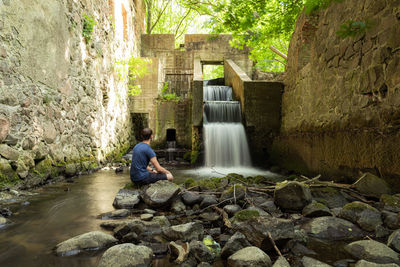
[311,187,348,209]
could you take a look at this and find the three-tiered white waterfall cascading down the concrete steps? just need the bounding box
[203,86,251,167]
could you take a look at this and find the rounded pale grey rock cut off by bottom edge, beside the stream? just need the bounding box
[98,244,153,267]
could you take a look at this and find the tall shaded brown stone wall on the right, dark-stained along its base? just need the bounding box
[275,0,400,185]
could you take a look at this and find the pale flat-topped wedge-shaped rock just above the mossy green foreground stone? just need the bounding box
[162,222,204,241]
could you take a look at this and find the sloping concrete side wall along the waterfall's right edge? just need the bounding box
[224,60,283,164]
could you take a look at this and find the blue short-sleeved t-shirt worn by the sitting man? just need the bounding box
[130,143,156,181]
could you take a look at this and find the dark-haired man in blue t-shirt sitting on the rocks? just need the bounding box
[130,128,174,185]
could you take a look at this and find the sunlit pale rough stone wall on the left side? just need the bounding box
[0,0,144,186]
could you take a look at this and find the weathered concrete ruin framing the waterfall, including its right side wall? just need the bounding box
[131,34,283,163]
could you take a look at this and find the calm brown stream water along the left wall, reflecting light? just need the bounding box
[0,171,129,266]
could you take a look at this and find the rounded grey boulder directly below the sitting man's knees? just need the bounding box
[141,180,180,208]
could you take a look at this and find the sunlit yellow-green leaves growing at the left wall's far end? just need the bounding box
[115,57,151,96]
